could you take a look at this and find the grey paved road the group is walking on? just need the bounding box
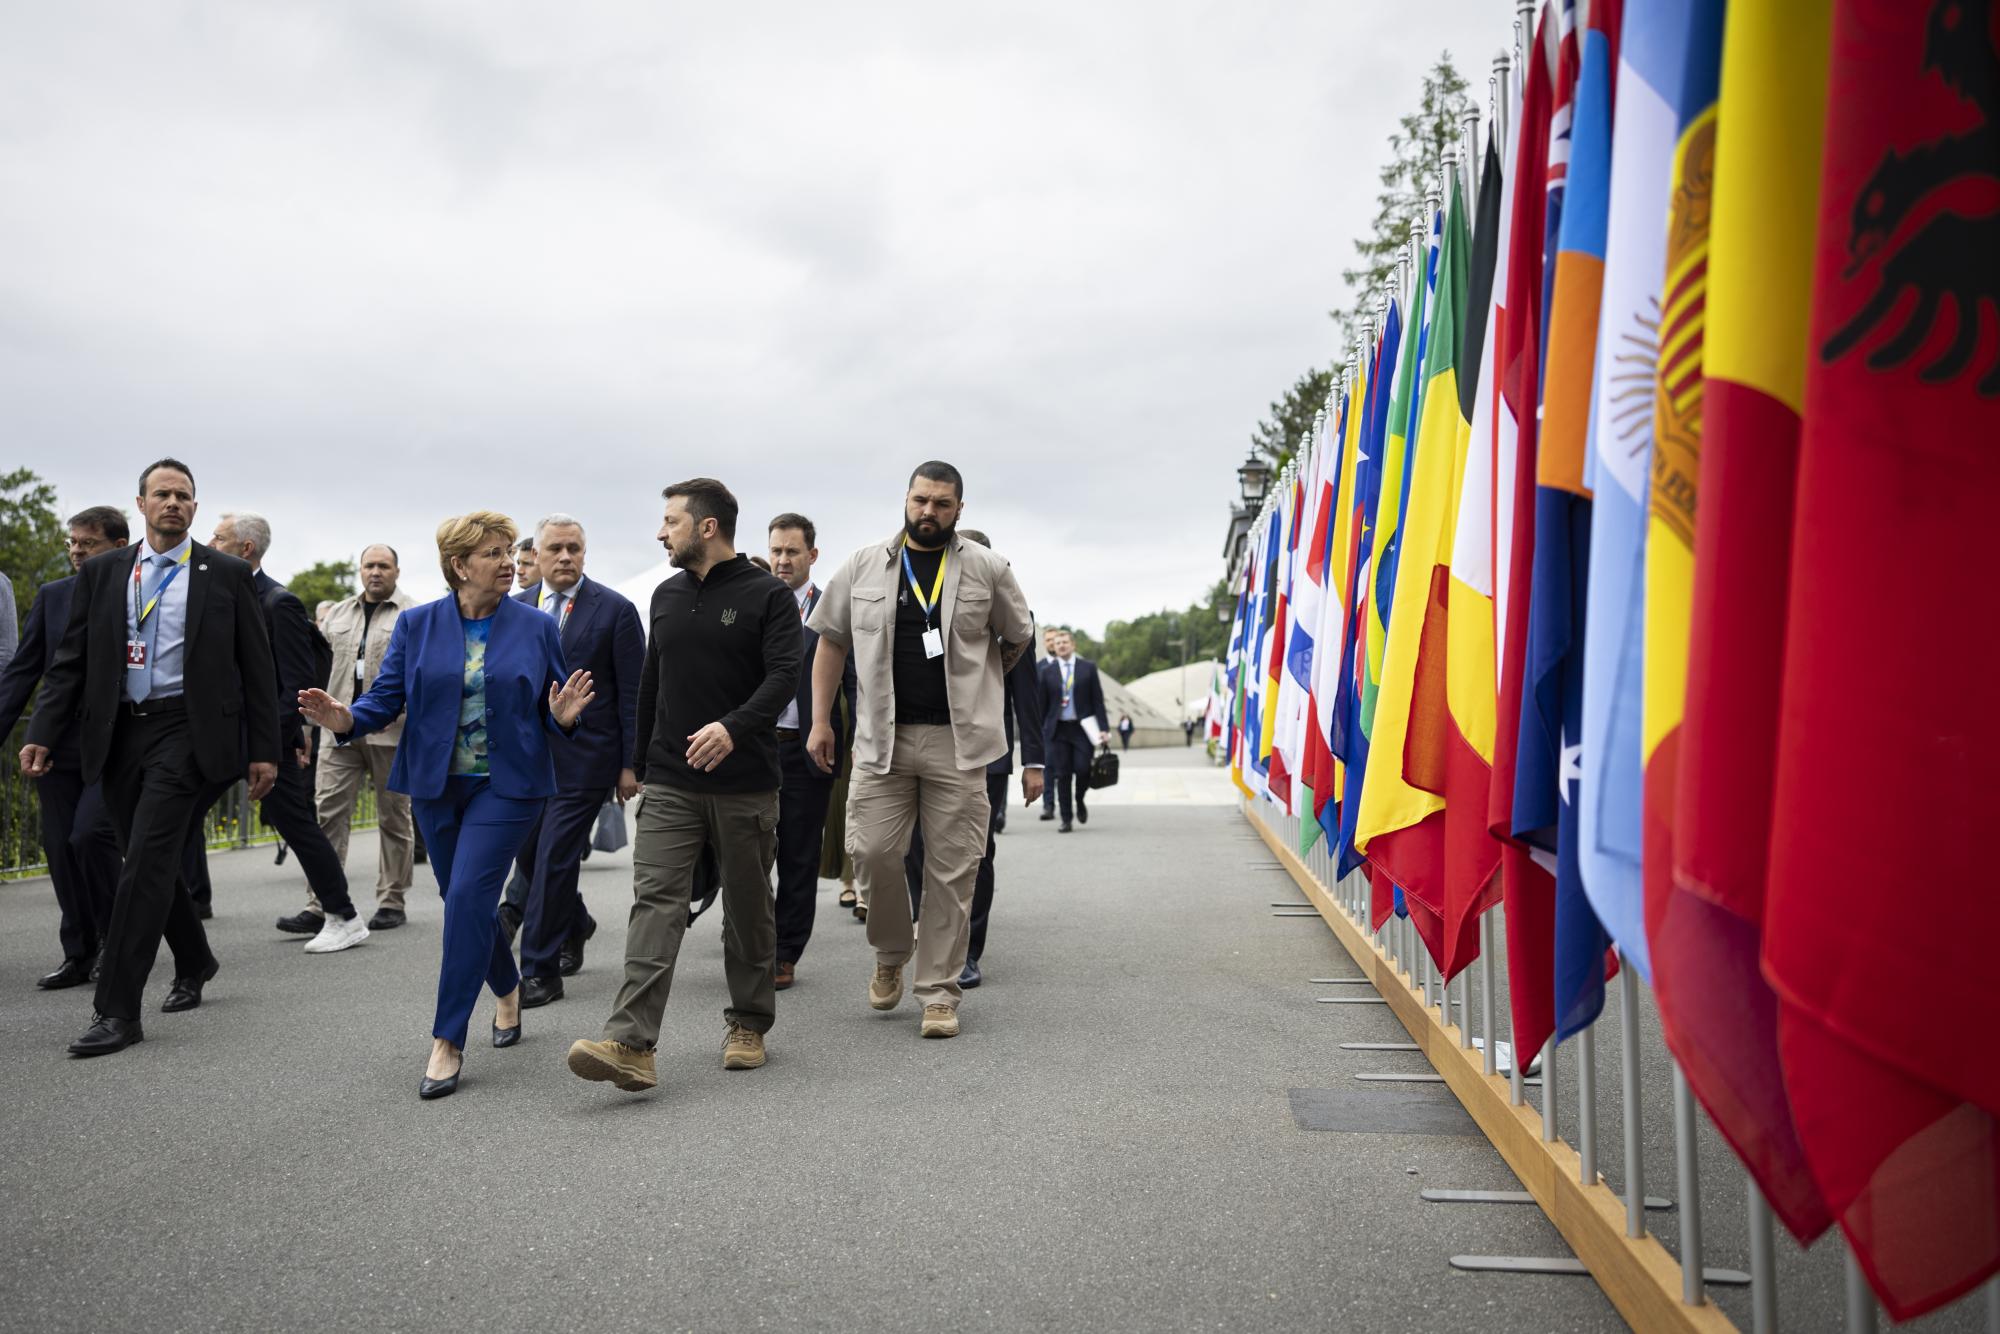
[0,750,1904,1334]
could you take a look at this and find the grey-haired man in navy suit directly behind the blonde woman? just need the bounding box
[516,514,646,1008]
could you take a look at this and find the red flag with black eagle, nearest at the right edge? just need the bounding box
[1764,0,2000,1320]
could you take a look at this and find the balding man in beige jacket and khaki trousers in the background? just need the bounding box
[298,544,416,932]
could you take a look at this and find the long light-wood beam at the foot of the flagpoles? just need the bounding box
[1242,802,1740,1334]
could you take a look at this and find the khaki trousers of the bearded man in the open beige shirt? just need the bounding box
[848,724,992,1010]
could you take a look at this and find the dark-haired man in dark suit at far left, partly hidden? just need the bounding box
[0,504,130,992]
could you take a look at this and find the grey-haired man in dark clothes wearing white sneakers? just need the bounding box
[210,510,368,954]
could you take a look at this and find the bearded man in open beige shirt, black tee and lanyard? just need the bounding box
[808,462,1034,1038]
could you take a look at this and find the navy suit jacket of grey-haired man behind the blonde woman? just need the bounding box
[514,578,646,790]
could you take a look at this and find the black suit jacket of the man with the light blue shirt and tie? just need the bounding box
[28,540,278,782]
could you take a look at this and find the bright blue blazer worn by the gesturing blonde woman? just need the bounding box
[340,594,570,800]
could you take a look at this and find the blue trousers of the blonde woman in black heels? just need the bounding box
[410,774,542,1050]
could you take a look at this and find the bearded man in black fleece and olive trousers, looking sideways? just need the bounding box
[570,478,800,1092]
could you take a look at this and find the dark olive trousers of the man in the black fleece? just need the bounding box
[604,782,778,1052]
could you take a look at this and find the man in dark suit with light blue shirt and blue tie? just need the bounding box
[20,458,278,1056]
